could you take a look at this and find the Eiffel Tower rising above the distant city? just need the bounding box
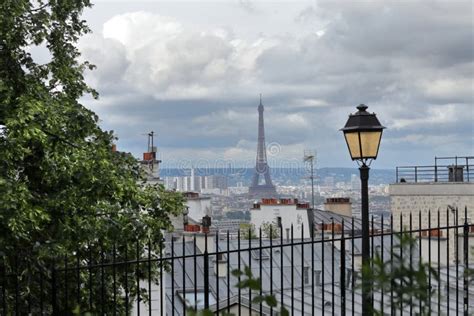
[249,95,277,198]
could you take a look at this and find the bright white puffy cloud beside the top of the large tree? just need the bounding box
[83,12,282,99]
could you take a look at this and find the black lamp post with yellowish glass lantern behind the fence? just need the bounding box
[341,104,385,316]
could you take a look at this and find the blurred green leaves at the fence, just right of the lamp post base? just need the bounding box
[362,233,439,315]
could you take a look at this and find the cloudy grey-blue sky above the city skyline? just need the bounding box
[80,0,474,168]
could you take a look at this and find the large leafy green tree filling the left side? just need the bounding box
[0,0,183,314]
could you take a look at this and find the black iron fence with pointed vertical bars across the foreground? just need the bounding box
[0,209,474,315]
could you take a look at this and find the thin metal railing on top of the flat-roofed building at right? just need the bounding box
[396,156,474,183]
